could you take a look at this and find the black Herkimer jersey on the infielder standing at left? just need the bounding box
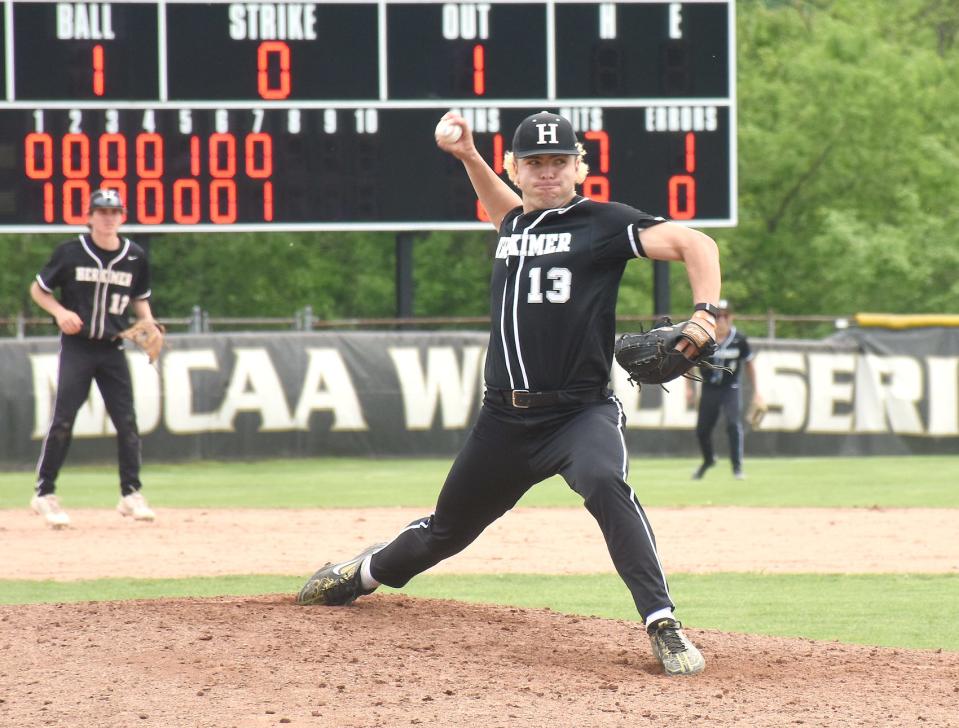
[37,235,150,339]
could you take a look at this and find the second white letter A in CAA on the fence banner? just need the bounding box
[293,349,369,432]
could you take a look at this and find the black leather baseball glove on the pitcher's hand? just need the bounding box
[613,317,716,387]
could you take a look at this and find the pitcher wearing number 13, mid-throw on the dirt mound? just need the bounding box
[297,112,720,675]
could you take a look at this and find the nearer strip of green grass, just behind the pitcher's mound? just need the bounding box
[0,573,959,651]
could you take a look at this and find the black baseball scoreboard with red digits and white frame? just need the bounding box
[0,0,736,232]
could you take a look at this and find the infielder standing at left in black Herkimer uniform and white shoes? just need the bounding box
[30,190,154,528]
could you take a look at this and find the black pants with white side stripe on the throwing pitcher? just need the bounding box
[370,396,673,616]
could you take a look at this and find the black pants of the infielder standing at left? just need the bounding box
[37,336,141,495]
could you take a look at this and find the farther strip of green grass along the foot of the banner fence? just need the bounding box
[0,456,959,508]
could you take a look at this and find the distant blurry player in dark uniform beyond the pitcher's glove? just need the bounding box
[687,300,763,480]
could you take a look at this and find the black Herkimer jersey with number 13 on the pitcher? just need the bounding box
[486,196,665,391]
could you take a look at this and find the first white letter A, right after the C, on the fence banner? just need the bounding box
[219,347,293,432]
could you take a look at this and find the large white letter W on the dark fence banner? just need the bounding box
[389,346,483,430]
